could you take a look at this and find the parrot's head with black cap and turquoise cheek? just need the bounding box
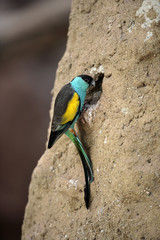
[71,75,95,91]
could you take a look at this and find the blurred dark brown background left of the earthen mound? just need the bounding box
[0,0,71,240]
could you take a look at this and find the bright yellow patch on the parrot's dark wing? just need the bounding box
[61,92,80,124]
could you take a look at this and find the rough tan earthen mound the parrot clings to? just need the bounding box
[22,0,160,240]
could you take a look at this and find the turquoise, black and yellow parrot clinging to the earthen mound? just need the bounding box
[48,75,95,209]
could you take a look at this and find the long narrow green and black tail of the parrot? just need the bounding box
[65,130,94,209]
